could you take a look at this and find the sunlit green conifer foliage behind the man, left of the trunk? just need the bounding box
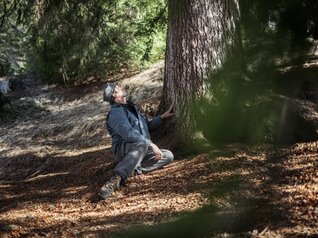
[1,0,167,83]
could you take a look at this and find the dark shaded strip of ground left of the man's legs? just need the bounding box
[0,149,114,212]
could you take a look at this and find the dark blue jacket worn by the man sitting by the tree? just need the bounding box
[106,102,163,154]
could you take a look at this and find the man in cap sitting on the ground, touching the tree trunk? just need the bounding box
[99,83,173,199]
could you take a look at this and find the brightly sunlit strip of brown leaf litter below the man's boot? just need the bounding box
[0,155,208,234]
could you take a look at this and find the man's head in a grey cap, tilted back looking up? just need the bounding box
[104,83,127,104]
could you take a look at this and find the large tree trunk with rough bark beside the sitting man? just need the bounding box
[162,0,241,140]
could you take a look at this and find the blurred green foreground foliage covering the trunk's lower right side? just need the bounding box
[195,64,278,144]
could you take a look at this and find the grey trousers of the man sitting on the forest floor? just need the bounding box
[114,142,173,180]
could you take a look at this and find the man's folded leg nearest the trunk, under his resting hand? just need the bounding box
[141,149,173,172]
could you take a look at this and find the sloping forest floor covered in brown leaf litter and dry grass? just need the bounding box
[0,62,318,237]
